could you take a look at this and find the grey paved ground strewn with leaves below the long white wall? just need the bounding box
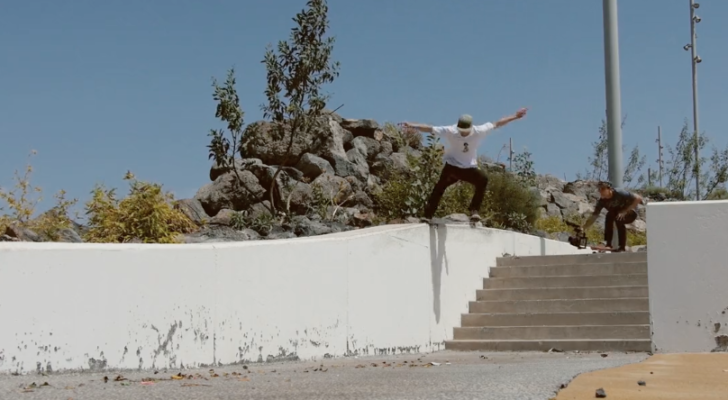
[0,351,647,400]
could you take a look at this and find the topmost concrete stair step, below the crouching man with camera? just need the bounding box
[496,252,647,267]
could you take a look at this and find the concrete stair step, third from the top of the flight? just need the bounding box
[483,274,647,289]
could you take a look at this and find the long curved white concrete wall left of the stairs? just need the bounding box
[0,225,580,373]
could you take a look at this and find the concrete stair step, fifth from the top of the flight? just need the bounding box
[469,297,649,314]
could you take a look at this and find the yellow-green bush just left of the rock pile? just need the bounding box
[85,173,196,243]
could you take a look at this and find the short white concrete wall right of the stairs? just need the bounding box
[647,201,728,352]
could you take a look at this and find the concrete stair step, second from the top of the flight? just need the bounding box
[490,262,647,278]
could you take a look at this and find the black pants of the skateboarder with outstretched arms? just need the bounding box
[425,163,488,218]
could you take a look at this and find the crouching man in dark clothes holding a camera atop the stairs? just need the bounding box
[581,182,642,252]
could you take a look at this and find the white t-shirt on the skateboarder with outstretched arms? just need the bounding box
[432,122,495,168]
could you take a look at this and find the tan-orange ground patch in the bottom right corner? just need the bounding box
[556,353,728,400]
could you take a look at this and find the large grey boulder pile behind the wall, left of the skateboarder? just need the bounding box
[177,112,420,242]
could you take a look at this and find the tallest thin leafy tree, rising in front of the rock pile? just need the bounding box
[261,0,339,214]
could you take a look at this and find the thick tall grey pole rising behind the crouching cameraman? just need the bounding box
[602,0,623,187]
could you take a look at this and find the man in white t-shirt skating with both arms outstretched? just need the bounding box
[403,108,528,223]
